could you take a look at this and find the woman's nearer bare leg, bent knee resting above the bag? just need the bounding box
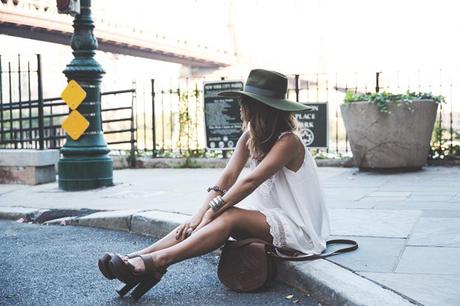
[130,207,273,272]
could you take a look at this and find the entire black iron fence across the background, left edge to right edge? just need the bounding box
[0,55,460,160]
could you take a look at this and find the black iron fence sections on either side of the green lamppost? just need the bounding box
[0,55,136,157]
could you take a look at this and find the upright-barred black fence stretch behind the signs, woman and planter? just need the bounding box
[132,70,460,158]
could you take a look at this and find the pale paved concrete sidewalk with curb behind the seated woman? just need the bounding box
[0,167,460,305]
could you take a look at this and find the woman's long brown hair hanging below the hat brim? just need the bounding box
[239,96,297,160]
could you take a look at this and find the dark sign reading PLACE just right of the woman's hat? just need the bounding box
[296,102,329,148]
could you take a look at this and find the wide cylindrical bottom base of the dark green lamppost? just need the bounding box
[58,155,113,191]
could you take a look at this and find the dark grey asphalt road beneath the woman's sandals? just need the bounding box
[0,220,320,305]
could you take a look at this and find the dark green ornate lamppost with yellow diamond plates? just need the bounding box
[57,0,113,190]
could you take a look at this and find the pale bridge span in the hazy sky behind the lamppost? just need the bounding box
[0,0,236,69]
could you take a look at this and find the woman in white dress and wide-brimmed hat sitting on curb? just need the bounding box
[99,69,330,299]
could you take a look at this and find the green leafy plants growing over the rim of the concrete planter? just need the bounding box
[344,90,445,113]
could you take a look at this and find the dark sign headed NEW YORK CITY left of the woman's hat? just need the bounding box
[203,81,243,150]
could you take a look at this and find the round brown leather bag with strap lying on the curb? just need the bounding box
[217,238,358,292]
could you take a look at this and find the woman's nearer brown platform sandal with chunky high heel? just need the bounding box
[109,254,167,300]
